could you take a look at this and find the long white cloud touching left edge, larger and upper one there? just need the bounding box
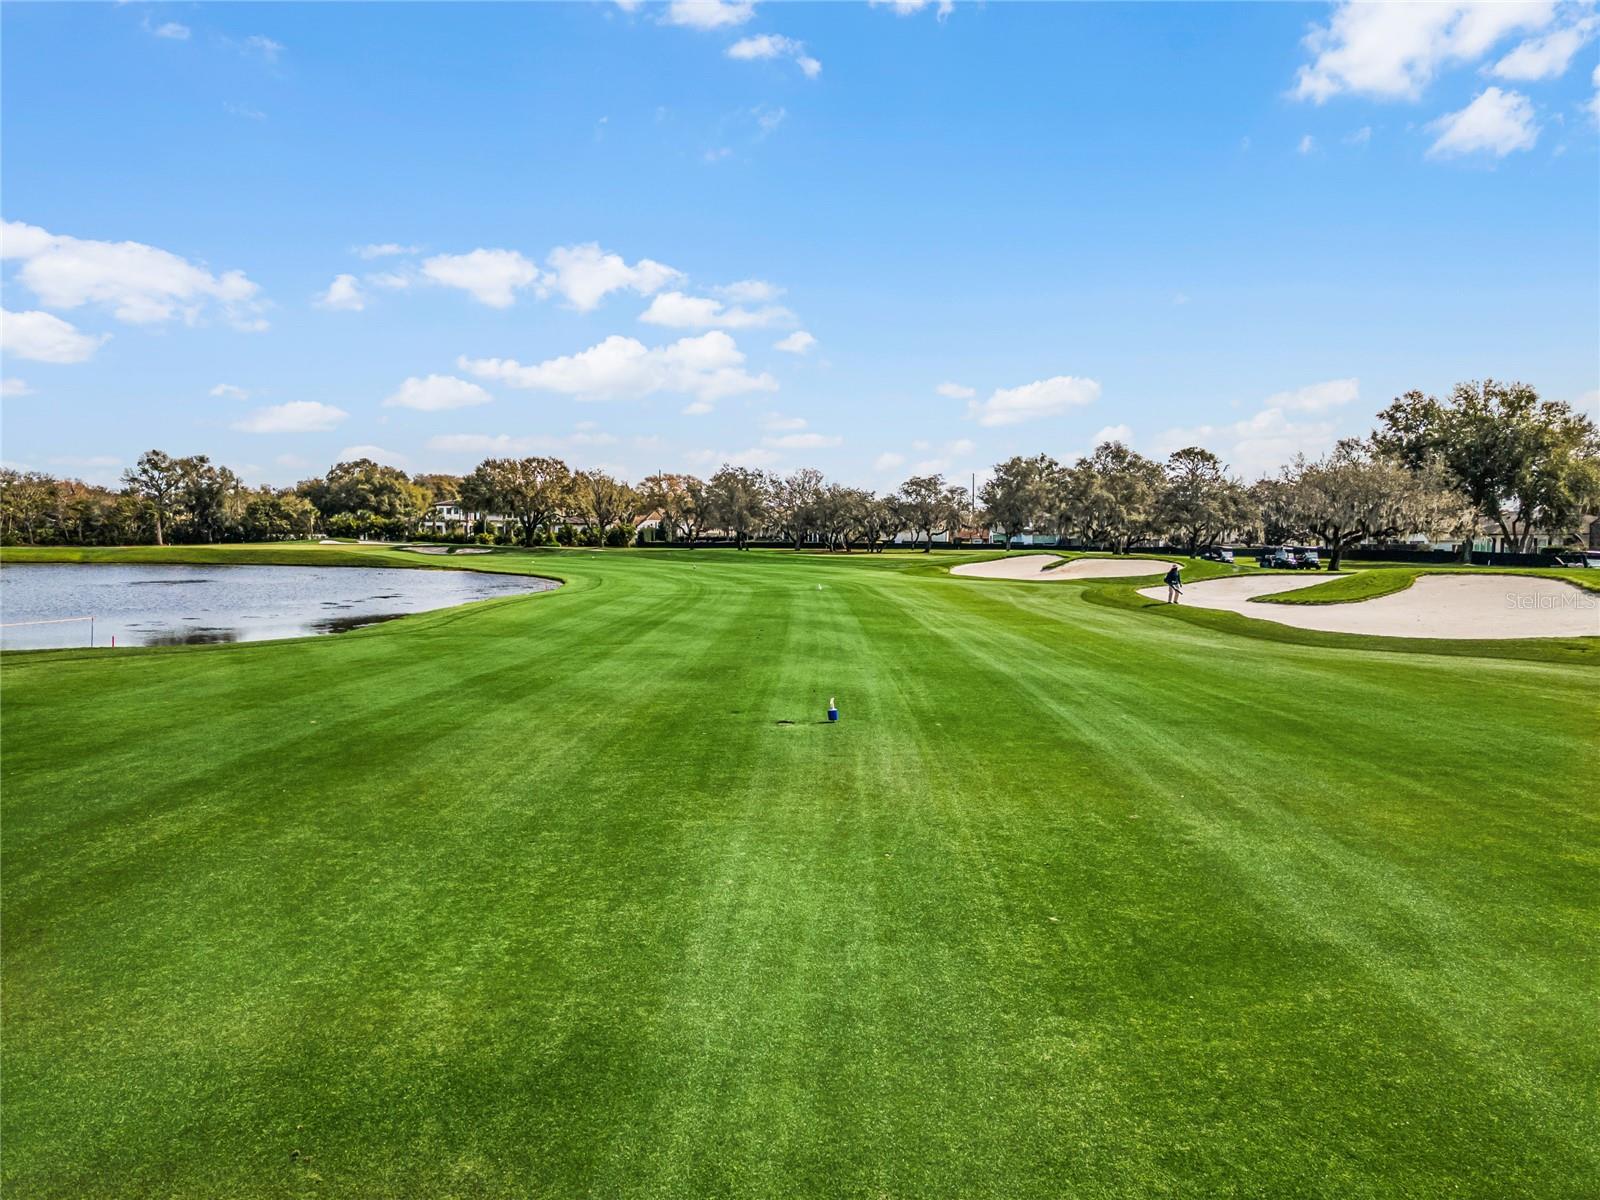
[0,221,266,330]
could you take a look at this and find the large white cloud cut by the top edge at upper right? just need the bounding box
[1291,0,1555,104]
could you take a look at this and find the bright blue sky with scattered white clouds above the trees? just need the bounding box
[0,0,1600,488]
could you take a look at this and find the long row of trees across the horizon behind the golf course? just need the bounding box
[0,381,1600,568]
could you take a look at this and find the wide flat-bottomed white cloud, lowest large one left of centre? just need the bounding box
[458,330,778,402]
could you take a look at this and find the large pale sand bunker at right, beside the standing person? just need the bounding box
[1139,574,1600,638]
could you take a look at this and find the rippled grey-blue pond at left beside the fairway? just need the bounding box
[0,563,560,650]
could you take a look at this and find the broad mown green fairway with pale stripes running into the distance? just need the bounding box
[0,547,1600,1200]
